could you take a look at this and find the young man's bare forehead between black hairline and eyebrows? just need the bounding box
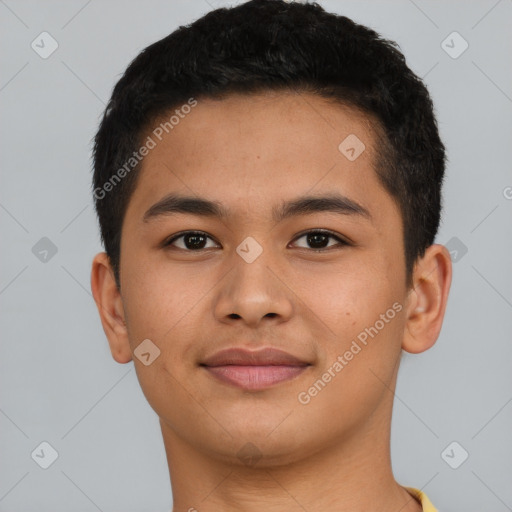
[129,92,394,226]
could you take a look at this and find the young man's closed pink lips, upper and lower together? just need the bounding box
[201,348,311,391]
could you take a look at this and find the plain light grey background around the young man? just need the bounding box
[0,0,512,512]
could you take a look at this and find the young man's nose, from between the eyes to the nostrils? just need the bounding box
[215,237,292,326]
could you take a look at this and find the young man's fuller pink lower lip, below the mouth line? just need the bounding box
[205,365,307,391]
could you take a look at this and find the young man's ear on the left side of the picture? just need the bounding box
[91,252,132,363]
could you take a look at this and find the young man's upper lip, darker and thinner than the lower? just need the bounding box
[201,348,309,366]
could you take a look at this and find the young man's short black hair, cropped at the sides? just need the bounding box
[93,0,445,287]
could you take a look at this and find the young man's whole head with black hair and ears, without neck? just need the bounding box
[92,0,451,468]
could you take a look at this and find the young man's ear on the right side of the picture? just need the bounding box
[402,244,452,354]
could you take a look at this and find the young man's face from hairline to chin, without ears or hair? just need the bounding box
[113,93,408,464]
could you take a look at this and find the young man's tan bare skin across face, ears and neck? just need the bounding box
[91,92,452,512]
